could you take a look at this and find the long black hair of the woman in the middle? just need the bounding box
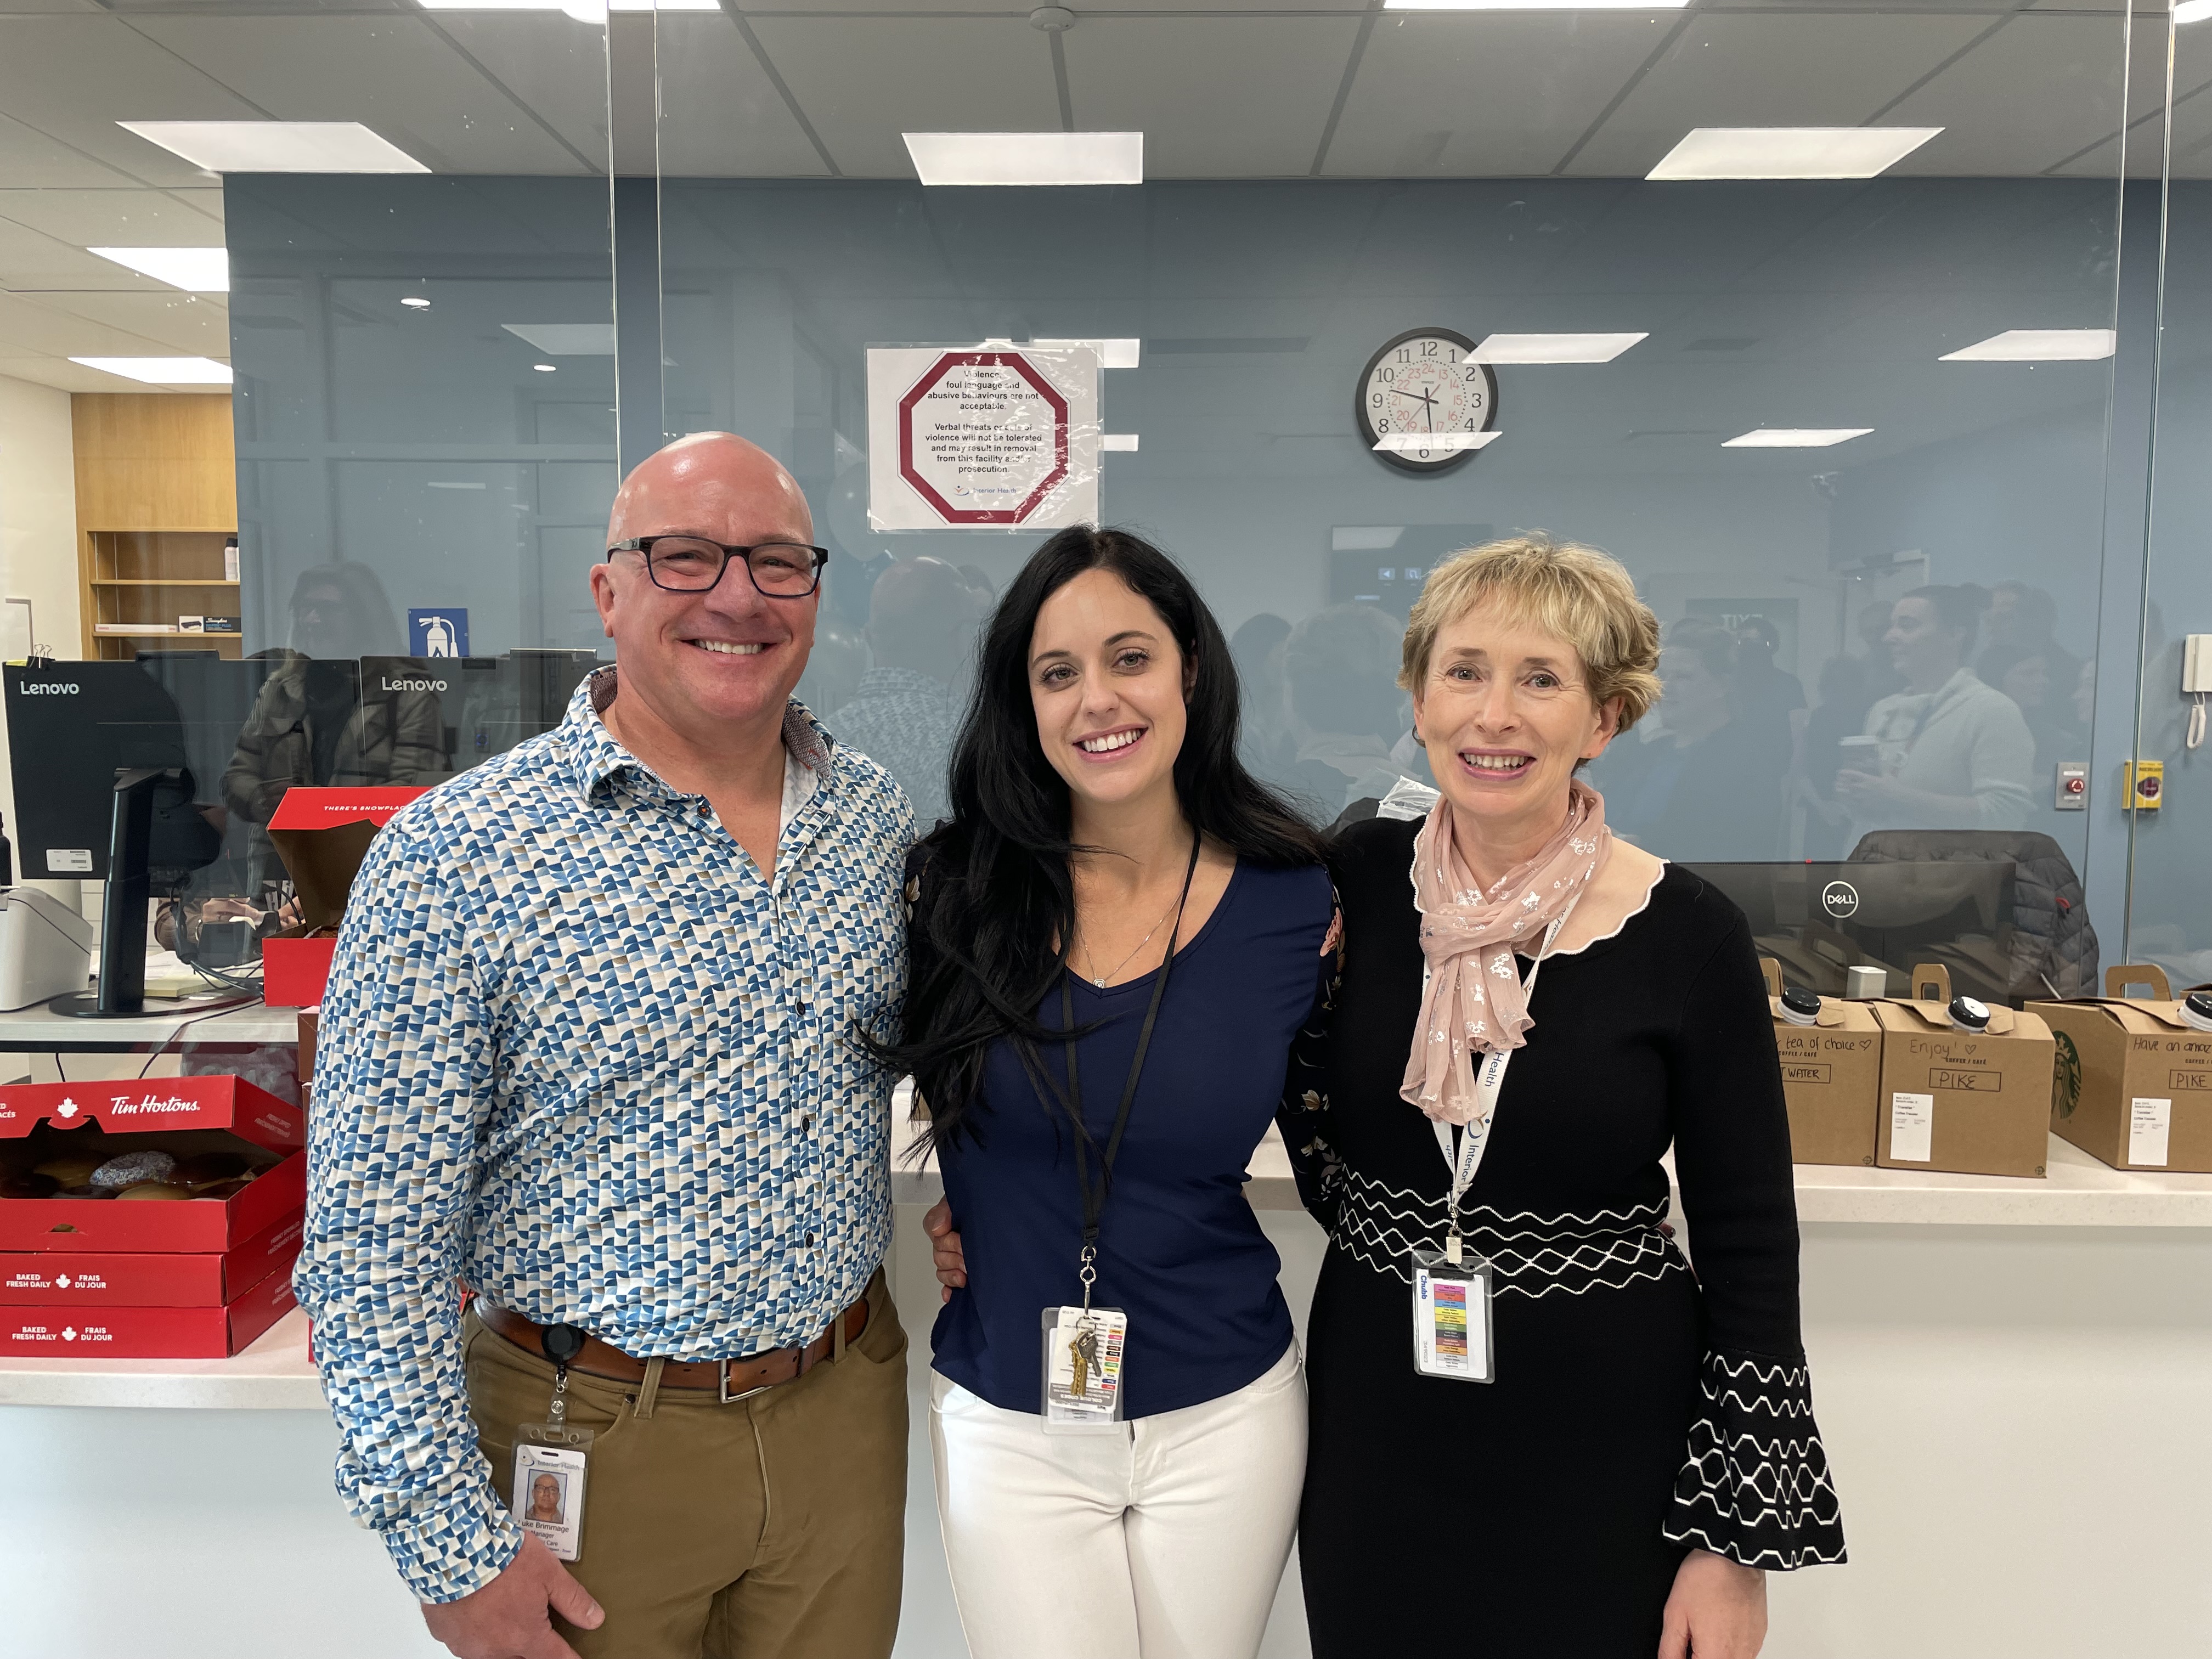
[878,527,1321,1142]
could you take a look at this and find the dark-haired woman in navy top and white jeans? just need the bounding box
[894,529,1331,1659]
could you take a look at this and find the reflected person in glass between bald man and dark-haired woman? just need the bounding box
[827,557,982,825]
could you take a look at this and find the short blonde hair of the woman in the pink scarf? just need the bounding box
[1398,531,1659,732]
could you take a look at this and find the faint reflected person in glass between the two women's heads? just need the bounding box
[1283,604,1404,823]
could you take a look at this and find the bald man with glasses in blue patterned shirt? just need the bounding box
[296,433,913,1659]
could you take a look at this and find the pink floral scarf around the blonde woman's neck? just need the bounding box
[1398,778,1612,1124]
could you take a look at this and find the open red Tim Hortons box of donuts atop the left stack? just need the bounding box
[0,1077,307,1254]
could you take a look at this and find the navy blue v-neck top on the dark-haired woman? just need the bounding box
[931,862,1331,1418]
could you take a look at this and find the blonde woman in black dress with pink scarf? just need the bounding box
[1283,535,1843,1659]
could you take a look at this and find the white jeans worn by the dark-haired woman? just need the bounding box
[929,1342,1305,1659]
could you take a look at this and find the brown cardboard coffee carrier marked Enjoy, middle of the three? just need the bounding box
[1869,962,2053,1177]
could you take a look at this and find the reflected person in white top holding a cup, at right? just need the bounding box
[1836,586,2035,847]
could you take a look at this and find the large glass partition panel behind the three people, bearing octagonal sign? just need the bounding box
[646,4,2157,995]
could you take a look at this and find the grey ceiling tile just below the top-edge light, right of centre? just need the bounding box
[1325,11,1672,177]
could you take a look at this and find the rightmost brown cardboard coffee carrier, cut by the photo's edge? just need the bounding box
[2028,967,2212,1175]
